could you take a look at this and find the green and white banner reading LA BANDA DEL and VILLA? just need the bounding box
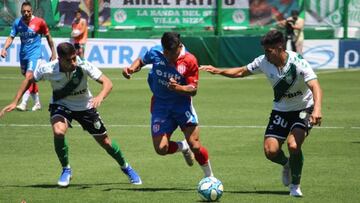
[110,0,216,28]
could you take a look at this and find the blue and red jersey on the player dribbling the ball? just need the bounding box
[142,46,199,102]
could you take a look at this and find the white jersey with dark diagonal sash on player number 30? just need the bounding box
[247,51,317,112]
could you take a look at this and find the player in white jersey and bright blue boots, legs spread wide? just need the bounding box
[0,42,142,187]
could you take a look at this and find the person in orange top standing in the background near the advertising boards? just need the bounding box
[71,9,88,60]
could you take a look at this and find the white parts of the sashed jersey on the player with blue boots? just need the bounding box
[34,57,102,111]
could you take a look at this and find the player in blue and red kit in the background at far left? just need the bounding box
[1,1,56,111]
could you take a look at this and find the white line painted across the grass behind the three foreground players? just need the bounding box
[0,124,360,130]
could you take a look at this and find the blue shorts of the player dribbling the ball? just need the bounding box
[151,99,198,136]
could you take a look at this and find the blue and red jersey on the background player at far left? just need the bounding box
[10,16,49,60]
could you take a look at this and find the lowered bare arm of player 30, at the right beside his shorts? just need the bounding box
[307,80,322,126]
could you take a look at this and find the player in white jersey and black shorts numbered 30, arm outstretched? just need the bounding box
[200,30,322,197]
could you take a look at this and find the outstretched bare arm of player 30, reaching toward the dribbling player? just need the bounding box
[199,65,251,78]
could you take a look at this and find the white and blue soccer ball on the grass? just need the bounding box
[198,177,224,202]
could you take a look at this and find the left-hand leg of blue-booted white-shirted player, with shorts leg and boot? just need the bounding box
[49,105,72,187]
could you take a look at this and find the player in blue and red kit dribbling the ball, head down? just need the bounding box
[123,32,213,177]
